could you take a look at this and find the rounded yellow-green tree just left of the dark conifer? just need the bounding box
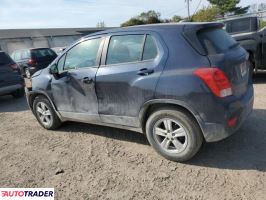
[191,6,220,22]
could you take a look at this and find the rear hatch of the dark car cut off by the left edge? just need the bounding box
[0,52,22,87]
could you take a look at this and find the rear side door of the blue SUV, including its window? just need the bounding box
[96,32,166,127]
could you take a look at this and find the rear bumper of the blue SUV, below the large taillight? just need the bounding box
[201,87,254,142]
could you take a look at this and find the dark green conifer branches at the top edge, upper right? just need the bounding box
[208,0,240,14]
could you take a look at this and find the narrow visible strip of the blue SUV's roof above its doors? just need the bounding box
[83,22,222,38]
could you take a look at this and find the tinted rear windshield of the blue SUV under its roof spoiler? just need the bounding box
[198,28,237,54]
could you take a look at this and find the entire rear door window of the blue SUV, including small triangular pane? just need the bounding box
[106,35,158,65]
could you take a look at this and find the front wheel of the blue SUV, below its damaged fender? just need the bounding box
[33,96,62,130]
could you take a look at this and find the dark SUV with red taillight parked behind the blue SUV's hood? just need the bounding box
[11,48,57,77]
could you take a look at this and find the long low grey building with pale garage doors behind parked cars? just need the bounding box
[0,27,107,54]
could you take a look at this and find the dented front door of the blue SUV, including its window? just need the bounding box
[51,38,103,122]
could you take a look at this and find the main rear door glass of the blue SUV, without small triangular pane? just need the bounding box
[106,35,145,65]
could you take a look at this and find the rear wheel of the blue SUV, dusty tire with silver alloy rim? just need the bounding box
[146,107,203,162]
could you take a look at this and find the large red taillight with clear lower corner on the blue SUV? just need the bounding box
[194,67,233,97]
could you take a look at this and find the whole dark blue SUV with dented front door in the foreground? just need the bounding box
[23,23,253,161]
